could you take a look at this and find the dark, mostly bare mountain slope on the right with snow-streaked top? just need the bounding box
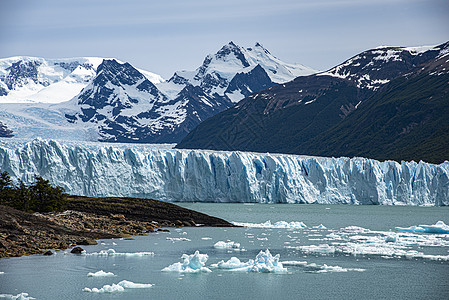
[177,42,449,163]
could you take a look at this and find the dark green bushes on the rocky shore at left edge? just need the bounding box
[0,172,67,212]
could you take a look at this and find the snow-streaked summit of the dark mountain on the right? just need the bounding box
[318,43,447,90]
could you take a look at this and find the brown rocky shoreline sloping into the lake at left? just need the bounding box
[0,196,233,258]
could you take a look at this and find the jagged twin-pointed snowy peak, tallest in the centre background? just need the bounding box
[160,42,318,102]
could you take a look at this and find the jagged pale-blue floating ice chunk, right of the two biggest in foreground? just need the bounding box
[213,249,287,273]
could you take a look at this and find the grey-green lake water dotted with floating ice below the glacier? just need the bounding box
[0,203,449,300]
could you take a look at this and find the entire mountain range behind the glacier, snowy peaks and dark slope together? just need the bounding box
[0,42,449,163]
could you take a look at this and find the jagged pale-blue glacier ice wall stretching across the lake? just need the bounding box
[0,139,449,206]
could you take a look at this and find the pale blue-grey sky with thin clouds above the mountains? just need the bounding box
[0,0,449,78]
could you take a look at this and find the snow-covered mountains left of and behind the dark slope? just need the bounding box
[0,42,317,143]
